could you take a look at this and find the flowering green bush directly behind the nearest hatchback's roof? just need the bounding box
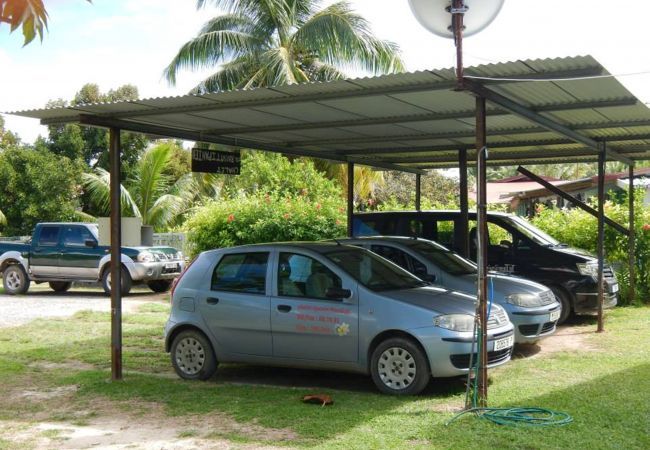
[185,194,346,254]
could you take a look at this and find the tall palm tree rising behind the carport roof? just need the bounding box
[164,0,404,93]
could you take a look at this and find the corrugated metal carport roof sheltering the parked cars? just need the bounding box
[12,56,650,168]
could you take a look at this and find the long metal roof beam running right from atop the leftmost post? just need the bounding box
[79,115,426,174]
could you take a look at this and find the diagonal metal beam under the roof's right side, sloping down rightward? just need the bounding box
[464,79,634,164]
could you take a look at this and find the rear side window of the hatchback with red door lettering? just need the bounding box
[212,253,269,294]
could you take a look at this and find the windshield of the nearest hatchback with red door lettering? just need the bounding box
[325,247,429,291]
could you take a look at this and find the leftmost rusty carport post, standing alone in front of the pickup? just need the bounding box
[108,128,122,381]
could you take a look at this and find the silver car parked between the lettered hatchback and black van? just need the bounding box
[338,236,562,344]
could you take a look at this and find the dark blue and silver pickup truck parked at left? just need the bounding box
[0,223,184,295]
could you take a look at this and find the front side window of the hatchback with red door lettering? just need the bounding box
[278,253,341,299]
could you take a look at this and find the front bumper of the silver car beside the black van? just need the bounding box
[506,302,562,344]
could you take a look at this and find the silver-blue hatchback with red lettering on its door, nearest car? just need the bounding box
[165,243,514,394]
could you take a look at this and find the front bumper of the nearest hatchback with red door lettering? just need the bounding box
[409,323,514,377]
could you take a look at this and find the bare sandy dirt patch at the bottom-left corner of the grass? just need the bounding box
[0,398,297,450]
